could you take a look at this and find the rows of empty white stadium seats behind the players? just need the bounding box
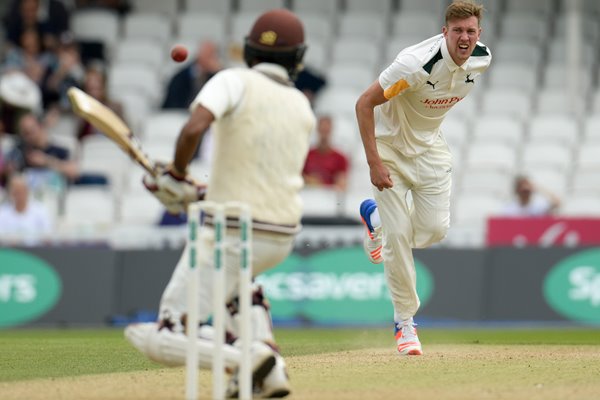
[29,0,600,245]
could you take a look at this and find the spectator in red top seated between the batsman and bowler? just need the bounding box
[302,116,348,191]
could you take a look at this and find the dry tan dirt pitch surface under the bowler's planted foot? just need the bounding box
[0,344,600,400]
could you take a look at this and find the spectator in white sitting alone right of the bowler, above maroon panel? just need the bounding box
[503,175,560,217]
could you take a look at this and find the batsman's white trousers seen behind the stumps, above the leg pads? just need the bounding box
[159,227,294,321]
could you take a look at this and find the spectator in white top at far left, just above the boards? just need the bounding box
[0,175,52,246]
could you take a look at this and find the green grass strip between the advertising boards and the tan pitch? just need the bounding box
[0,328,600,382]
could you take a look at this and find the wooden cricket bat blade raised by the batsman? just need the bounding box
[67,87,158,176]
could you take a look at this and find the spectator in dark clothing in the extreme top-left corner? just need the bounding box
[4,0,69,51]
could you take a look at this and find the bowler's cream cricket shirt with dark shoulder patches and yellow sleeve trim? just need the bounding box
[375,34,492,157]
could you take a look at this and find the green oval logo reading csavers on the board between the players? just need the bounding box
[257,246,434,324]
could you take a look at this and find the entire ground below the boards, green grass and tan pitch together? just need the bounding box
[0,327,600,400]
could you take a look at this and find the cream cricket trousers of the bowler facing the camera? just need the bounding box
[373,135,452,322]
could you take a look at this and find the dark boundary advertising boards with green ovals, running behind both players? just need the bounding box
[0,246,600,328]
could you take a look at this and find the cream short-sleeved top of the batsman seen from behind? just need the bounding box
[190,63,315,233]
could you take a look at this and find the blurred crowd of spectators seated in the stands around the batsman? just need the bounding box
[0,0,349,244]
